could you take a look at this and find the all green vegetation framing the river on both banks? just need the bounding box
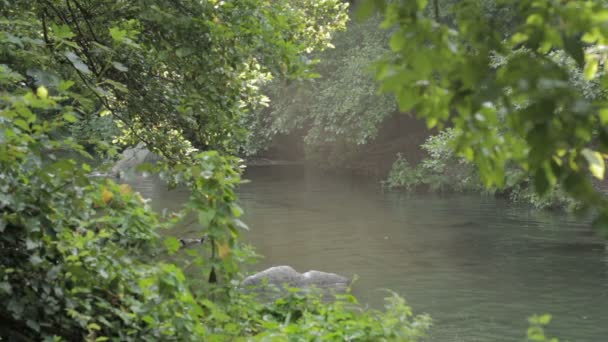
[0,0,608,341]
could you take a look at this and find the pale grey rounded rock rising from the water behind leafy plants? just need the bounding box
[242,266,350,295]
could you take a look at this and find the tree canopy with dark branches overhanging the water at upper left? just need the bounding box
[0,0,346,155]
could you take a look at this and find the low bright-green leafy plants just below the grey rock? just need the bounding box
[256,293,431,342]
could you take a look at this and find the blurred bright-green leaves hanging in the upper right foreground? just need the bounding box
[367,0,608,230]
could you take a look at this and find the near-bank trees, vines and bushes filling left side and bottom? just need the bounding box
[0,0,428,341]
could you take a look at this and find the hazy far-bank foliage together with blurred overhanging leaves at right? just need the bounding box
[251,0,606,216]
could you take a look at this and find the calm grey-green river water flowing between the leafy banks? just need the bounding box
[132,166,608,342]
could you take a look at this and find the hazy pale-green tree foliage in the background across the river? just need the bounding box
[244,17,396,161]
